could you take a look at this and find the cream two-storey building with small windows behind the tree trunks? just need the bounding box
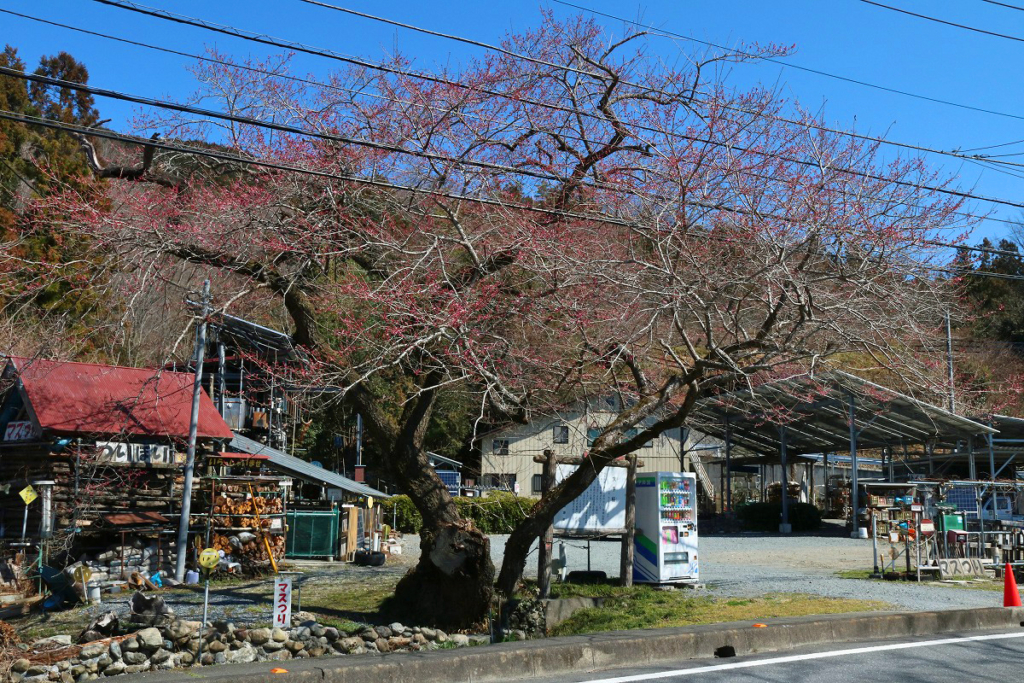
[480,397,714,498]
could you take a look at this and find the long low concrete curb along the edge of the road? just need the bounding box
[115,607,1024,683]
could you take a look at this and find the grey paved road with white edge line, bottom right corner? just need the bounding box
[538,630,1024,683]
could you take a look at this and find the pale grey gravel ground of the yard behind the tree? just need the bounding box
[28,533,1001,638]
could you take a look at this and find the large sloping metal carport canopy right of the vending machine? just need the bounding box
[687,370,997,455]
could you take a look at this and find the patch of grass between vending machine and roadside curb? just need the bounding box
[552,586,891,636]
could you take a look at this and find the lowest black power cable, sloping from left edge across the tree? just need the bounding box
[0,110,1024,282]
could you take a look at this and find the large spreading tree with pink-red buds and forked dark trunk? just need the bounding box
[28,16,958,626]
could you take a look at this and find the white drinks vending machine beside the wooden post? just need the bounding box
[633,472,699,584]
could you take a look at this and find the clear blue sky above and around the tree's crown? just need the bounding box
[0,0,1024,242]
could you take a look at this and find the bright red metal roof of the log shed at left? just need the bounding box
[9,357,232,439]
